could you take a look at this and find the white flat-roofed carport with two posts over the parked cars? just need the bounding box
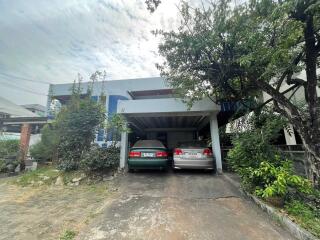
[117,98,222,173]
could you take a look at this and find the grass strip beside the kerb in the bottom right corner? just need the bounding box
[285,200,320,238]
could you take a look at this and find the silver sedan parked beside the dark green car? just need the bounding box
[173,141,214,170]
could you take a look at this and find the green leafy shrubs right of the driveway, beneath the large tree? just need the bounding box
[228,113,311,198]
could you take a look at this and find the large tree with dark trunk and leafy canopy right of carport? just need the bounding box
[156,0,320,183]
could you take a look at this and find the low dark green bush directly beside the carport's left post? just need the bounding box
[80,145,120,171]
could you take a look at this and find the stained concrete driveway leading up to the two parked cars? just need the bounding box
[78,171,295,240]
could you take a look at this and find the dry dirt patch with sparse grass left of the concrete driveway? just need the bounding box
[0,177,117,240]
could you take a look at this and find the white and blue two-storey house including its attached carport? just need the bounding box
[47,77,237,172]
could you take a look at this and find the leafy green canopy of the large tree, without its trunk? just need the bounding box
[156,0,319,105]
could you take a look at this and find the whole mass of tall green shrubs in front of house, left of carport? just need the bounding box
[30,72,123,171]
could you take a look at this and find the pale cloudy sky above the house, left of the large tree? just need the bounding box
[0,0,185,105]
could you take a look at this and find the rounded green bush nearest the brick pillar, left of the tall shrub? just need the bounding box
[30,123,59,162]
